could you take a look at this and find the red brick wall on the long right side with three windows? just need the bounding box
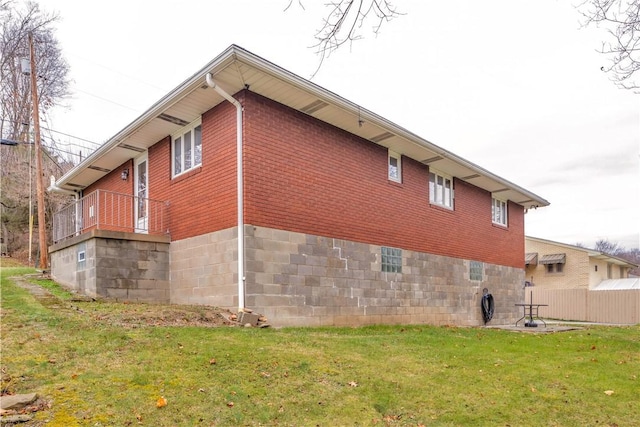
[243,93,524,268]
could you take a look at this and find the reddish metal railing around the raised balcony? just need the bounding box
[53,190,168,243]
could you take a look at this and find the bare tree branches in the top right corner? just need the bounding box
[578,0,640,91]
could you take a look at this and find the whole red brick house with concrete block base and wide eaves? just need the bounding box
[49,46,548,325]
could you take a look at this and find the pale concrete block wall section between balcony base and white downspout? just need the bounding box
[170,227,238,308]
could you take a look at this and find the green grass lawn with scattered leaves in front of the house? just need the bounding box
[1,267,640,427]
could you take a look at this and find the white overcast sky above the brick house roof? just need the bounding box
[40,0,640,248]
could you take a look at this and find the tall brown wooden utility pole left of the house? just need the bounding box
[29,33,48,271]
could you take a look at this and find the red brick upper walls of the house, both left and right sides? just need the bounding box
[85,91,524,268]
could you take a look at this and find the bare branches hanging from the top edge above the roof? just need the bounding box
[285,0,402,71]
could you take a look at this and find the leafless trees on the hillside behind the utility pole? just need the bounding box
[0,0,69,258]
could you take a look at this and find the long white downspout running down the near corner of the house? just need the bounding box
[207,73,244,311]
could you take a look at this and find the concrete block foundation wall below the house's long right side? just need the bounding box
[246,226,524,326]
